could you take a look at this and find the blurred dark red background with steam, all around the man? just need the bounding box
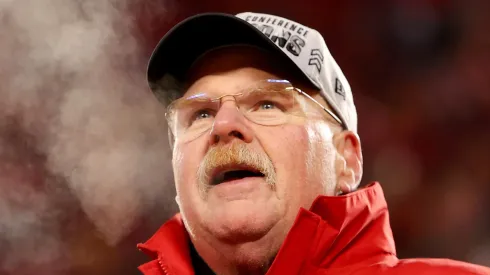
[0,0,490,275]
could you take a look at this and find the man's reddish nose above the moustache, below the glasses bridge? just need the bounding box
[209,101,253,145]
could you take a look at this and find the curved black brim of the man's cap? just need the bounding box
[147,13,315,85]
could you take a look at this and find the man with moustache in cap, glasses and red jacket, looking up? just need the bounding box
[138,13,490,274]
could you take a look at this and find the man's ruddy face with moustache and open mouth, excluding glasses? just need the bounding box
[173,47,336,246]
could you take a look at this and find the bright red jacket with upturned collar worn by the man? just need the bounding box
[138,183,490,275]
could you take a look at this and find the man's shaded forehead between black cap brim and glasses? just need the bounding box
[186,46,310,95]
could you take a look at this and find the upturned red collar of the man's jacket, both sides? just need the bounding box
[138,182,396,274]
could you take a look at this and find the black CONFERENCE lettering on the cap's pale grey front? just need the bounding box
[245,15,308,56]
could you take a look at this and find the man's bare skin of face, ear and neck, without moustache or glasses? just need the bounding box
[172,46,362,274]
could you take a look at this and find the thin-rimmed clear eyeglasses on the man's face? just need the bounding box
[165,79,345,143]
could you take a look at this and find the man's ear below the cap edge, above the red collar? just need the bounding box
[333,131,363,193]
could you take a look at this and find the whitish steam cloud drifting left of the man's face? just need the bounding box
[0,0,179,274]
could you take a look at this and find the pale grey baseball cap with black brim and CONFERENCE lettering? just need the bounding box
[147,12,357,132]
